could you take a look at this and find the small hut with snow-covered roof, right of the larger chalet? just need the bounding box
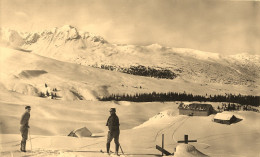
[214,113,237,125]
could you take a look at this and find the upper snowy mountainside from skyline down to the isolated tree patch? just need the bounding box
[0,25,260,88]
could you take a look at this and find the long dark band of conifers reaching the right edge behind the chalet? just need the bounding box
[99,92,260,106]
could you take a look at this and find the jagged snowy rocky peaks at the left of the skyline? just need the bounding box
[0,25,108,49]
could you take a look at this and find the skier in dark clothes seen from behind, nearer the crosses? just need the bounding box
[106,108,120,155]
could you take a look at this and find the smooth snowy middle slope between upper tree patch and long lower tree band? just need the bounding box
[0,47,259,100]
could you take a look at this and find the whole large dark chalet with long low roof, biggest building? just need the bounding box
[178,103,213,116]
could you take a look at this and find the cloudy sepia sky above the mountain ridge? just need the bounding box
[0,0,260,54]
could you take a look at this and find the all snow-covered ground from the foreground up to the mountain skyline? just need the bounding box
[0,26,260,157]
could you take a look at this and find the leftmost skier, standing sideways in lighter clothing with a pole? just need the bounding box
[20,106,31,152]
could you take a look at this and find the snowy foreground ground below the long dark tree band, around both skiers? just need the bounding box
[0,93,260,157]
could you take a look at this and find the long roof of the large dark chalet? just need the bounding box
[178,103,212,111]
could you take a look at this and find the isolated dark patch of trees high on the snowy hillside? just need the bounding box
[94,64,177,79]
